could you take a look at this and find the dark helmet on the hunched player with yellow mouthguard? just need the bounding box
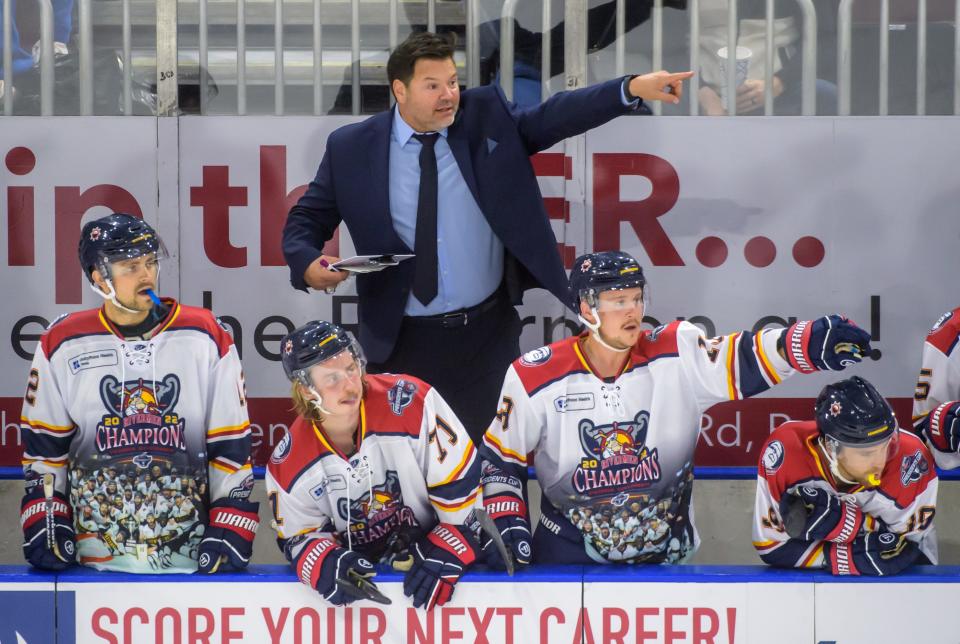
[815,376,897,447]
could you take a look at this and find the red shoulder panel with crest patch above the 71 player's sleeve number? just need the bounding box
[363,373,430,438]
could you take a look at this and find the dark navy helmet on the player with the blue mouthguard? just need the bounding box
[78,212,167,282]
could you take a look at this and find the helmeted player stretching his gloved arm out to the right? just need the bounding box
[481,252,870,563]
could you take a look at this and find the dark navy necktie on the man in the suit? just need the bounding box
[413,133,439,305]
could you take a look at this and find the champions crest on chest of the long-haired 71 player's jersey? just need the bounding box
[337,470,418,545]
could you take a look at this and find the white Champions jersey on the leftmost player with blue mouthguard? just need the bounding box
[21,299,253,572]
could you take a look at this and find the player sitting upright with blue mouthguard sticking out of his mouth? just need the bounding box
[20,213,258,573]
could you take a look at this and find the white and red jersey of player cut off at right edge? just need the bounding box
[913,308,960,469]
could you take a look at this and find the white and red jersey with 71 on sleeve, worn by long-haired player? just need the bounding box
[266,374,480,562]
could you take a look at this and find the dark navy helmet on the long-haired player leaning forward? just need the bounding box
[280,320,367,387]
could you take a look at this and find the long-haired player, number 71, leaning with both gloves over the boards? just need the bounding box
[266,322,480,610]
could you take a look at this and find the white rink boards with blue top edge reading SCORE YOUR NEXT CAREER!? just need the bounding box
[0,566,960,644]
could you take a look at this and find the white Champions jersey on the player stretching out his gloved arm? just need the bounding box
[481,322,793,563]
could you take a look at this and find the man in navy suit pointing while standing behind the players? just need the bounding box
[283,33,692,441]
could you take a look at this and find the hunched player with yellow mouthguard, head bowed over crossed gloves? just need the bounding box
[753,376,937,576]
